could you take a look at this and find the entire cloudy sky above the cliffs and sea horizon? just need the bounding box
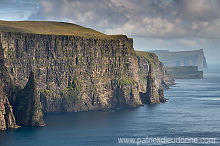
[0,0,220,64]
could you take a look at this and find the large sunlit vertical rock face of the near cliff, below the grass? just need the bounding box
[1,33,141,112]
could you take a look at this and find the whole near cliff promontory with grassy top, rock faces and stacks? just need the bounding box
[0,21,173,129]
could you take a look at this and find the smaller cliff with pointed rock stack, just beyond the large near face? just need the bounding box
[136,51,175,103]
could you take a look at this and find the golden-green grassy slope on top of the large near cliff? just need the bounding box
[0,21,125,39]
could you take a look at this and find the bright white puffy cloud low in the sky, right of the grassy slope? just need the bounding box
[106,17,189,38]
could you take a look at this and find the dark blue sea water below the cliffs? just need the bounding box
[0,65,220,146]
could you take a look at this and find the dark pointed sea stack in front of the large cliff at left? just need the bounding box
[14,72,45,126]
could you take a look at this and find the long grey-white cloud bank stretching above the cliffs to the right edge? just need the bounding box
[26,0,220,38]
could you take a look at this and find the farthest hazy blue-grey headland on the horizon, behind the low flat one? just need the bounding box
[151,49,207,68]
